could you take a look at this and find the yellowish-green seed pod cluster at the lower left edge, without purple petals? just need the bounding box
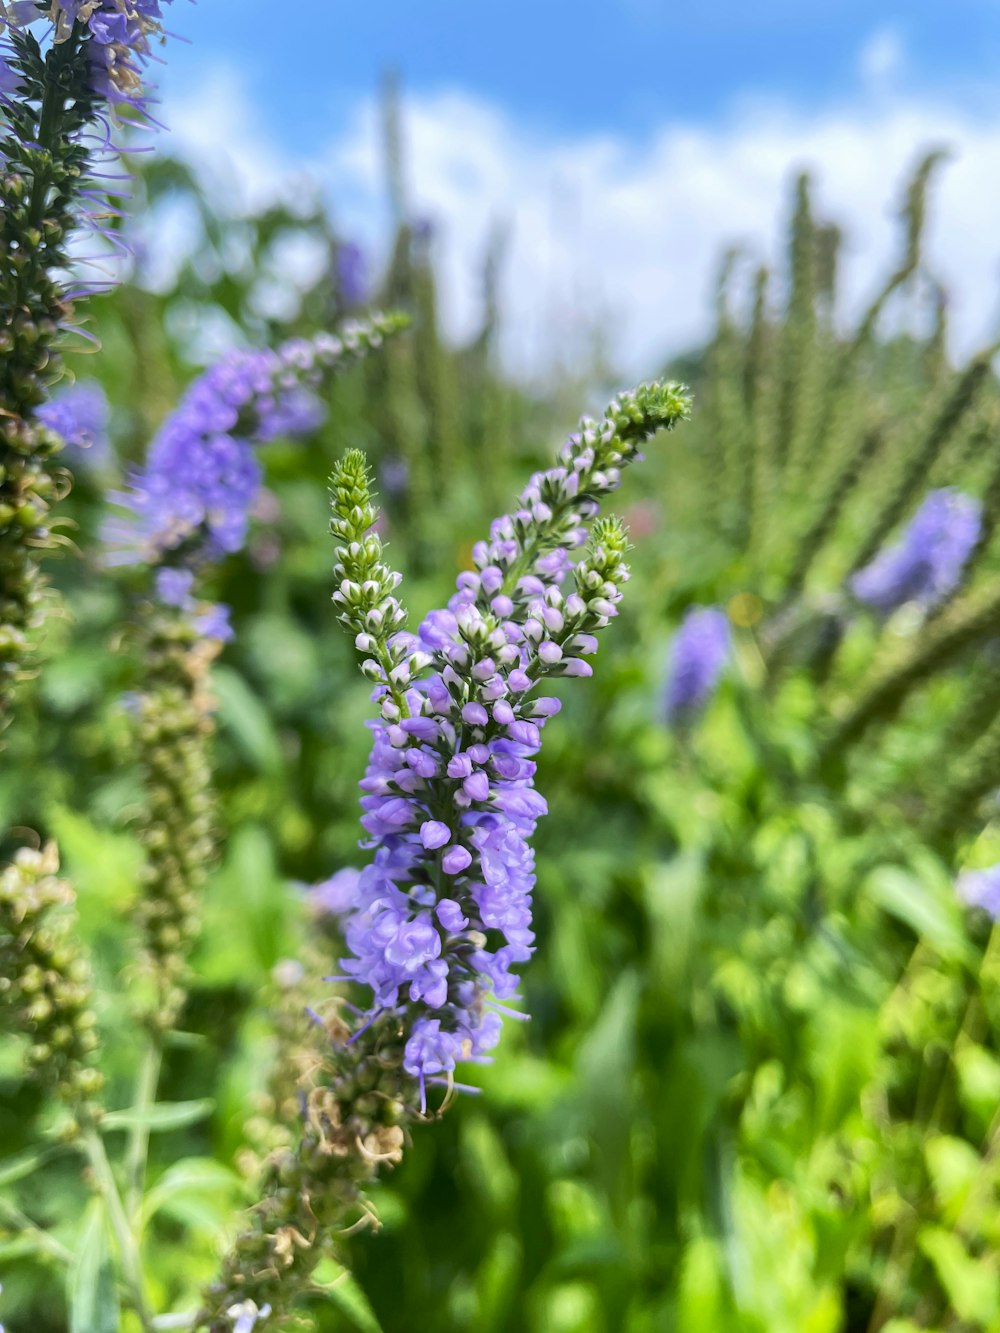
[0,845,101,1106]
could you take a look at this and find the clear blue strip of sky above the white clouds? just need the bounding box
[165,0,1000,144]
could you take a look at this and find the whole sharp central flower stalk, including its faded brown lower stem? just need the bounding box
[197,384,688,1333]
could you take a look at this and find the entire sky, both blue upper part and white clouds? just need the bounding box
[161,0,1000,373]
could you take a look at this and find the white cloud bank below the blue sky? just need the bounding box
[160,64,1000,375]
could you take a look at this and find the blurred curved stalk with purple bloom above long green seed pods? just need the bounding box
[116,315,405,1247]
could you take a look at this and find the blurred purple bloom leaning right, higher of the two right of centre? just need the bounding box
[851,487,983,615]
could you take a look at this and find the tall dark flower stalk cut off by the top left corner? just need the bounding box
[0,0,178,724]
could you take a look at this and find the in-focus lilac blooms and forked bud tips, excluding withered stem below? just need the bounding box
[325,384,688,1108]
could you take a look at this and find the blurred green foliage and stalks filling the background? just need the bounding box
[0,88,1000,1333]
